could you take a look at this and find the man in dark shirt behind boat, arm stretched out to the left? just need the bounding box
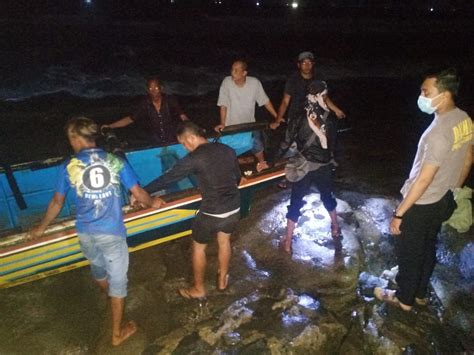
[102,77,188,144]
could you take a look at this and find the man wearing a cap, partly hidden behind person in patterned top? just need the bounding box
[271,52,346,129]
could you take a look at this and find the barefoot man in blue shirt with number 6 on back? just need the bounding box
[30,117,163,346]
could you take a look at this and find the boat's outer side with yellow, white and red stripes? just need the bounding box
[0,159,284,288]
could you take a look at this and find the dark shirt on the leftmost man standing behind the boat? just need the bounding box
[131,94,184,144]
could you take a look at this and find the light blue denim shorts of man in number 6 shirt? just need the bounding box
[78,234,128,298]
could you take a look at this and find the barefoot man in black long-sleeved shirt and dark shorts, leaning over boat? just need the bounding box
[145,121,240,299]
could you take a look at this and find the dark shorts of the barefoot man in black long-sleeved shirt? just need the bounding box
[193,212,240,244]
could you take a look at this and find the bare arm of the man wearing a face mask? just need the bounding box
[390,164,439,234]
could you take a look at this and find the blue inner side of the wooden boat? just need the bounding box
[0,132,252,234]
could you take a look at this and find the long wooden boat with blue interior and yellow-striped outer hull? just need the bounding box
[0,125,284,288]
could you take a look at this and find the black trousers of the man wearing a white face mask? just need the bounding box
[394,191,456,306]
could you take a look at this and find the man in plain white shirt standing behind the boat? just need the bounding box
[215,59,277,171]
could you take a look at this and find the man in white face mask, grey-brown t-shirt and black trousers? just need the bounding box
[374,69,473,311]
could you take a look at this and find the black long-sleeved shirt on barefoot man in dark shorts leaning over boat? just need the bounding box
[145,143,240,214]
